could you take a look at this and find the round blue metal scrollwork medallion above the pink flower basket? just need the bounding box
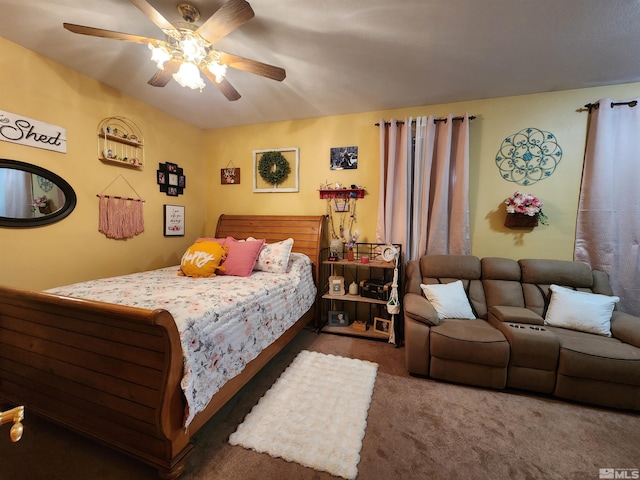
[496,128,562,185]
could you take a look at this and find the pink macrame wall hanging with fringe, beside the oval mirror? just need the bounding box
[98,175,144,240]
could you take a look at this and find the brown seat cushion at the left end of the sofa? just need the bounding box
[429,319,509,367]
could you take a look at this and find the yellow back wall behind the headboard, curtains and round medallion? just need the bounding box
[205,83,640,260]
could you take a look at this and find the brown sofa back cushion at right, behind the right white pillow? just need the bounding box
[518,259,593,317]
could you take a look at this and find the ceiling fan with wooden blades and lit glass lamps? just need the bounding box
[63,0,286,101]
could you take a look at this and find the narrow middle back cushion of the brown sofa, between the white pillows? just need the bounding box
[481,257,525,309]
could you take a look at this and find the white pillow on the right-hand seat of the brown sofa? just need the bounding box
[544,285,620,337]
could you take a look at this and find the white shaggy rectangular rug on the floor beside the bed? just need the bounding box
[229,350,378,479]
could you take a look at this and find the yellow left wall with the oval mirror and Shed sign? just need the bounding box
[0,38,207,289]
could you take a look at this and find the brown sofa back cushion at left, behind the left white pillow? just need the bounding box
[419,255,487,320]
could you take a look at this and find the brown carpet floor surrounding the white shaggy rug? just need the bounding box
[0,331,640,480]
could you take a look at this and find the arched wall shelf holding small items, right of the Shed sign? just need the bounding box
[98,117,144,170]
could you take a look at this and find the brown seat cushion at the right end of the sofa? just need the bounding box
[545,327,640,386]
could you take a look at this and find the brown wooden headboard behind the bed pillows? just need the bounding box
[215,215,325,281]
